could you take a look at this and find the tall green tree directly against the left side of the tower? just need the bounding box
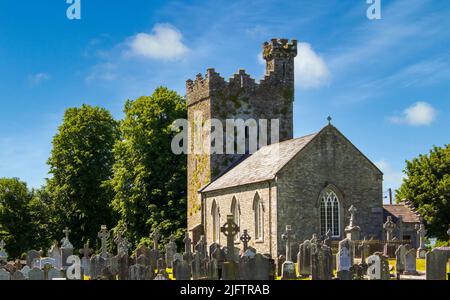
[111,87,186,244]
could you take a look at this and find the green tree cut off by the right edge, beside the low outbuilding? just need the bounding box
[396,145,450,241]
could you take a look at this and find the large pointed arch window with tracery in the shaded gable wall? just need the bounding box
[320,189,341,237]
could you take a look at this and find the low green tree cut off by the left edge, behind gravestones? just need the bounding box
[0,178,33,258]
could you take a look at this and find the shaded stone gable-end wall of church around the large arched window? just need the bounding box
[277,126,383,253]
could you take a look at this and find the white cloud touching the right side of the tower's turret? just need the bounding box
[295,43,331,89]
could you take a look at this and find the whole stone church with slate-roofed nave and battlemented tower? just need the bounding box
[186,39,383,257]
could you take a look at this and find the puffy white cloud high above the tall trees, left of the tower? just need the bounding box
[127,24,189,60]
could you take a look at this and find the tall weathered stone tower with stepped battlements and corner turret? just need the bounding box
[186,39,297,241]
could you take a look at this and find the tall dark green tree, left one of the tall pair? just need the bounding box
[47,105,118,247]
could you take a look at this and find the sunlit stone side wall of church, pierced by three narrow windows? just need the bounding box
[204,182,277,257]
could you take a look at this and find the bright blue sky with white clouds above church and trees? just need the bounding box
[0,0,450,202]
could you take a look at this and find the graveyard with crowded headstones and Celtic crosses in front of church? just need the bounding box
[0,209,450,281]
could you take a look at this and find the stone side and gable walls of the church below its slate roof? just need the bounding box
[203,125,383,257]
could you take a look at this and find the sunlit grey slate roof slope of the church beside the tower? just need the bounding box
[200,133,318,192]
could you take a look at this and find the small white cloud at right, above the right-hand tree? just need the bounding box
[391,102,437,126]
